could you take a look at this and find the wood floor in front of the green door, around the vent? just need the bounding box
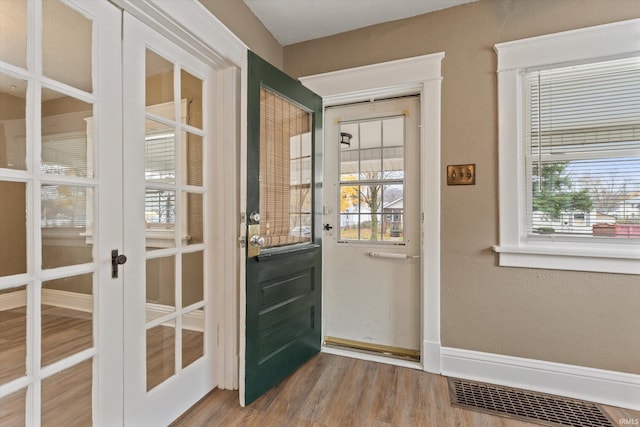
[171,354,640,427]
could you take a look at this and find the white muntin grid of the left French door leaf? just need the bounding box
[0,2,99,425]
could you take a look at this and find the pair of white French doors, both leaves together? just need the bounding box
[0,0,224,427]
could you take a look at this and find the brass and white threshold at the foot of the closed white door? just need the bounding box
[322,337,422,369]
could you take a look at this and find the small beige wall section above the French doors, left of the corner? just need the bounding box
[199,0,282,69]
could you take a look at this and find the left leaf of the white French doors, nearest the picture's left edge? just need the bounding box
[0,0,121,427]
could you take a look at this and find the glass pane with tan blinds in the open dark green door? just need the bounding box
[260,89,312,247]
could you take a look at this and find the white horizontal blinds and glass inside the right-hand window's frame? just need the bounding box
[525,57,640,238]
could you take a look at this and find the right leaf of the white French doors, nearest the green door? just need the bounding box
[123,12,217,426]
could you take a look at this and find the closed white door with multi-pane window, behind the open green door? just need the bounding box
[323,96,422,358]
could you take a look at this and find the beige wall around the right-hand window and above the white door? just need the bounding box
[284,0,640,374]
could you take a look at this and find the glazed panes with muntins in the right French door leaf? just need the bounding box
[144,48,205,391]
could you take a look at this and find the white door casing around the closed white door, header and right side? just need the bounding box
[300,53,444,373]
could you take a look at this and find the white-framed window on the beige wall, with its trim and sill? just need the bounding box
[495,19,640,274]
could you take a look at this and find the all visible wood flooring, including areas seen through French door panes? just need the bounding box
[0,306,640,427]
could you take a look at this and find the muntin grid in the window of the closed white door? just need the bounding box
[337,115,406,245]
